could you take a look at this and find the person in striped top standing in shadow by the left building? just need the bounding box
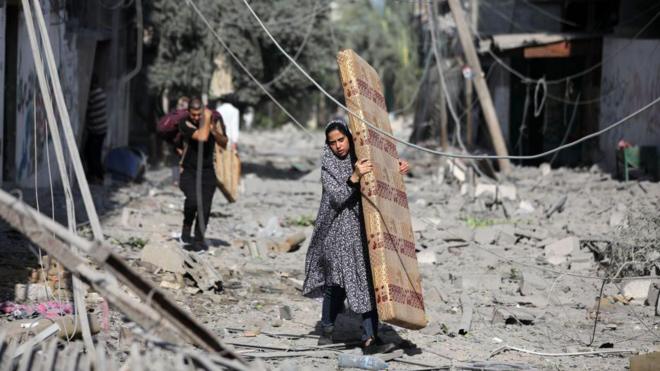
[85,75,108,184]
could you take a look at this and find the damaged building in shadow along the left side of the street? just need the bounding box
[0,0,139,188]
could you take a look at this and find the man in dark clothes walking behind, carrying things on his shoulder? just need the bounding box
[179,98,227,245]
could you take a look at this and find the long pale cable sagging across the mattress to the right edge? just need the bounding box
[232,0,660,160]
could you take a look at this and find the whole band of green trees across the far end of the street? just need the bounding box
[145,0,419,124]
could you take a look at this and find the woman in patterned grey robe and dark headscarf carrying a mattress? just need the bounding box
[303,120,408,354]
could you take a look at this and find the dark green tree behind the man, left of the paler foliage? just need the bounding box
[149,0,337,105]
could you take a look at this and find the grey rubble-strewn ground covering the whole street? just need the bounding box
[3,127,660,370]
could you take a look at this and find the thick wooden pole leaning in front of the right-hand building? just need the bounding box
[449,0,511,174]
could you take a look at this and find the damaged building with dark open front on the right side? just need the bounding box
[416,0,660,179]
